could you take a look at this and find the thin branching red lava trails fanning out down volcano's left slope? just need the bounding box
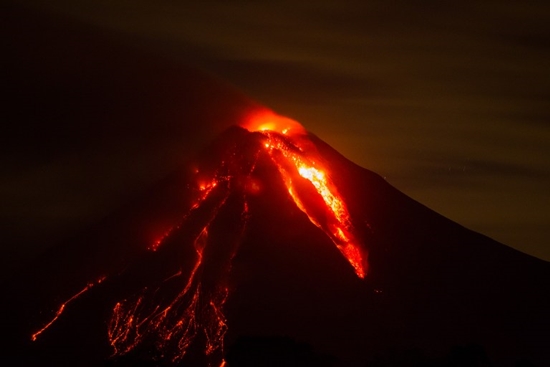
[108,157,257,367]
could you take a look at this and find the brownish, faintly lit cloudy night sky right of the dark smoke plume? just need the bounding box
[4,0,550,270]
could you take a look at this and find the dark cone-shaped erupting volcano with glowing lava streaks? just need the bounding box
[2,110,550,366]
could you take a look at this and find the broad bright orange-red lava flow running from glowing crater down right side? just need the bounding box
[244,112,367,278]
